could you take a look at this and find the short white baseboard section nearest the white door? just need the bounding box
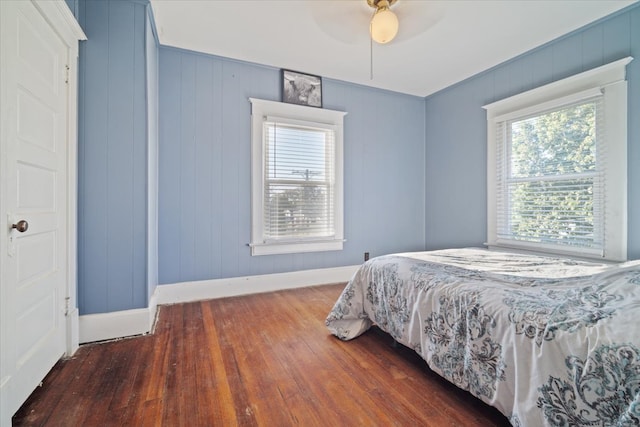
[79,288,158,344]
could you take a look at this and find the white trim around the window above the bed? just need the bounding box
[483,56,633,261]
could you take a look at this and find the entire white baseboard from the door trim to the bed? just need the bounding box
[79,265,359,344]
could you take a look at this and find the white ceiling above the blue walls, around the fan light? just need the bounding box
[151,0,635,96]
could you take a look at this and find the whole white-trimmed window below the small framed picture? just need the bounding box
[250,98,346,255]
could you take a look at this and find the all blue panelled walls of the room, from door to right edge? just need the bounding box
[74,0,640,314]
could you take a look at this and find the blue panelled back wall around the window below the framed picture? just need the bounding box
[159,48,425,283]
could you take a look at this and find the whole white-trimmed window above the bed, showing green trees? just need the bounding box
[484,58,631,261]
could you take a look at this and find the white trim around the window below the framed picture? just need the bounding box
[249,98,347,256]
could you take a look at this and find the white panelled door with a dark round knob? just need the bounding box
[0,0,74,424]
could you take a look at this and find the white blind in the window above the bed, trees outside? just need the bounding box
[496,96,606,253]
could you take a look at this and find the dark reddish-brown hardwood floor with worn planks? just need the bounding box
[13,284,509,427]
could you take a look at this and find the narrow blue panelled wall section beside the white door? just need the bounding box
[76,0,149,314]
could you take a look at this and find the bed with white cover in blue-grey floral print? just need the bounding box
[326,248,640,427]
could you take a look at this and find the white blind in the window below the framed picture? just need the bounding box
[263,117,335,242]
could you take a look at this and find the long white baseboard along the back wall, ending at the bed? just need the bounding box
[157,265,359,304]
